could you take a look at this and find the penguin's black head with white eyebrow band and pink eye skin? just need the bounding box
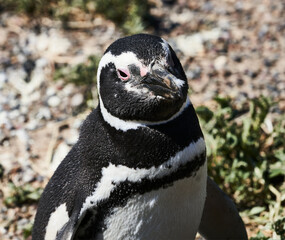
[97,34,188,123]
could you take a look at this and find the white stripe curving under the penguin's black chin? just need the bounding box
[99,97,192,132]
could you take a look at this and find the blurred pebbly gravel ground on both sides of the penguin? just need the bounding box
[0,0,285,239]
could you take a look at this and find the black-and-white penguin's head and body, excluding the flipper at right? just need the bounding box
[33,34,207,240]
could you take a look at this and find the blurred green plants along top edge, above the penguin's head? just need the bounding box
[0,0,150,34]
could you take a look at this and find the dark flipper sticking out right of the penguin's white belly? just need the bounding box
[198,177,248,239]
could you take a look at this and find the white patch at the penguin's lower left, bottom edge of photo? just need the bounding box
[45,203,69,240]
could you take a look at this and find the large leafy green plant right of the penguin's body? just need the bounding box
[196,97,285,239]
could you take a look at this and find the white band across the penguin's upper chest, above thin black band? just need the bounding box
[79,138,206,216]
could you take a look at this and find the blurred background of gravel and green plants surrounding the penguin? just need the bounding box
[0,0,285,240]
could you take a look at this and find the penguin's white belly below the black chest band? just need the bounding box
[103,162,207,240]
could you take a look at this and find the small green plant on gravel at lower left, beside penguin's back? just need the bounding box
[4,182,43,207]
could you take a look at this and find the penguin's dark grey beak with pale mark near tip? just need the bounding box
[141,64,182,98]
